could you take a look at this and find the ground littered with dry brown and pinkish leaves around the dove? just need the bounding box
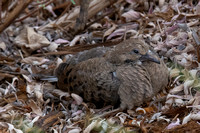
[0,0,200,133]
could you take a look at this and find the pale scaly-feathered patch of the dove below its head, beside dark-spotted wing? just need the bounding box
[117,64,153,109]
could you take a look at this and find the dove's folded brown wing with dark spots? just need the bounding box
[58,58,120,103]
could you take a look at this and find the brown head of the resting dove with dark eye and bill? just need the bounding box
[106,39,160,65]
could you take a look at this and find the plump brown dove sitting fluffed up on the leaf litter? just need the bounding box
[55,38,169,110]
